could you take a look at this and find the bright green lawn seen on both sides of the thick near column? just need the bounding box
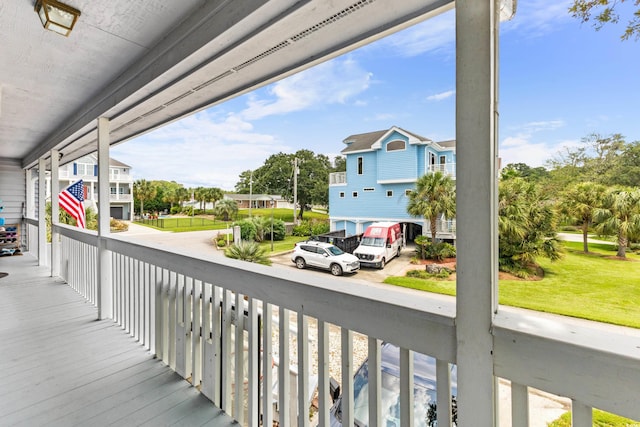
[385,242,640,328]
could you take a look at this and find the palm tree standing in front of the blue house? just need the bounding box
[407,171,456,243]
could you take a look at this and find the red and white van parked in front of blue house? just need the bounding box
[353,222,403,269]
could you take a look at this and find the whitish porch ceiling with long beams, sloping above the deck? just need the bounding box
[0,0,453,171]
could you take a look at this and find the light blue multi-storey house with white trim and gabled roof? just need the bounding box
[329,126,456,240]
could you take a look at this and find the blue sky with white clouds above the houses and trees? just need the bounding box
[111,0,640,190]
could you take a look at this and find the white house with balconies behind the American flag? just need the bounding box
[47,154,133,220]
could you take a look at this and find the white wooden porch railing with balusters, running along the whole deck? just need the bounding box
[48,222,640,427]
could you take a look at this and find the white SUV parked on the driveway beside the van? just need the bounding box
[291,241,360,276]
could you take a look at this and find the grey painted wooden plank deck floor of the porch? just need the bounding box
[0,254,237,427]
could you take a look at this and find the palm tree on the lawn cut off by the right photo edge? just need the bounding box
[594,187,640,258]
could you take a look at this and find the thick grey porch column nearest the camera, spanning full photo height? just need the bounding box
[456,0,498,427]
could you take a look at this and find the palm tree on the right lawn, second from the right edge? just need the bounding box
[562,182,606,253]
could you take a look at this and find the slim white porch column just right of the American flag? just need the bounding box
[97,117,113,319]
